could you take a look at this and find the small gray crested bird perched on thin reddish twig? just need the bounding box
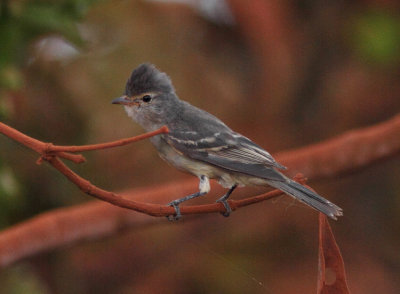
[112,63,342,219]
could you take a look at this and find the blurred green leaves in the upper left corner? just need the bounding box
[0,0,96,90]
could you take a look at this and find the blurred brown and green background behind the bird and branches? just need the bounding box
[0,0,400,294]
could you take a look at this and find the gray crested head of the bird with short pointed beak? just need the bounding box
[112,63,179,130]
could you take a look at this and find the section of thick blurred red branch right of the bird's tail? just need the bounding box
[276,114,400,180]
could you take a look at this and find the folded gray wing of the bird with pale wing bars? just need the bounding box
[164,129,285,180]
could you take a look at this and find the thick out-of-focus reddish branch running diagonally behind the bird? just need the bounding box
[0,115,400,267]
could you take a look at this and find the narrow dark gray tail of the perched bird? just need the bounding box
[268,179,343,220]
